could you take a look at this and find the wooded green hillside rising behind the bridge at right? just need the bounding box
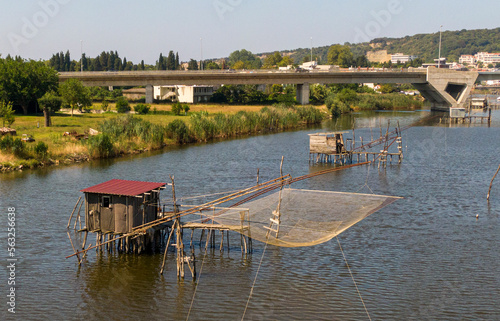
[268,28,500,63]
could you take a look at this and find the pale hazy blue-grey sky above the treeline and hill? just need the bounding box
[0,0,500,64]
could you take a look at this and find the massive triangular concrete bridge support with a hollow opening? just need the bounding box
[413,67,479,111]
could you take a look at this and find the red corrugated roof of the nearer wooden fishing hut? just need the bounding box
[80,179,166,196]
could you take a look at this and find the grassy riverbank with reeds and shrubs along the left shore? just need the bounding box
[0,105,325,171]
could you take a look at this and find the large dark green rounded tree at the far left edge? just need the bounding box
[0,58,59,115]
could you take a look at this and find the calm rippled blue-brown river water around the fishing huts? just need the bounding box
[0,111,500,320]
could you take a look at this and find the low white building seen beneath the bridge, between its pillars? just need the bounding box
[153,86,214,104]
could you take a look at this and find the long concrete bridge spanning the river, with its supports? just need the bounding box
[59,67,500,110]
